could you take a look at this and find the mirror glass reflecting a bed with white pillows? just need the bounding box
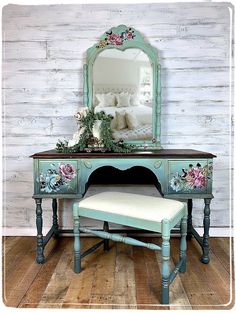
[93,48,153,141]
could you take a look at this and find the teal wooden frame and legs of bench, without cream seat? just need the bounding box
[73,196,187,304]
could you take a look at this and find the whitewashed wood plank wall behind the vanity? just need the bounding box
[3,2,231,235]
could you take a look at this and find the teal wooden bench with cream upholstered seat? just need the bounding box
[73,192,187,304]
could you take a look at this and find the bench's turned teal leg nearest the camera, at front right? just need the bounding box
[161,219,170,304]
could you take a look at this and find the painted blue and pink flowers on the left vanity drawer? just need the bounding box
[38,163,76,193]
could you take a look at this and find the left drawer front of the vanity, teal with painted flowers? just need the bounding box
[36,159,78,194]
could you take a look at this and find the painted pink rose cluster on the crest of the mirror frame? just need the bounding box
[96,28,135,48]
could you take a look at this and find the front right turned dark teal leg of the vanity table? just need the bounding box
[201,198,211,264]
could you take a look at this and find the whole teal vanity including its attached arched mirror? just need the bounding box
[31,25,215,263]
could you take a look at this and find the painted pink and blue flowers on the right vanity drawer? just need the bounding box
[170,163,212,192]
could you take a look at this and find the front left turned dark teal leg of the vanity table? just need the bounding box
[35,198,45,264]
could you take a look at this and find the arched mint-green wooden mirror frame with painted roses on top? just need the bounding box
[83,25,162,149]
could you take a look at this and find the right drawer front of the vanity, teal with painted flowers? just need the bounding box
[168,159,212,194]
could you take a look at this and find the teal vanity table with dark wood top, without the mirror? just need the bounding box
[32,149,215,263]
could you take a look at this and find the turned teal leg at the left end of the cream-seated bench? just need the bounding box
[73,206,81,273]
